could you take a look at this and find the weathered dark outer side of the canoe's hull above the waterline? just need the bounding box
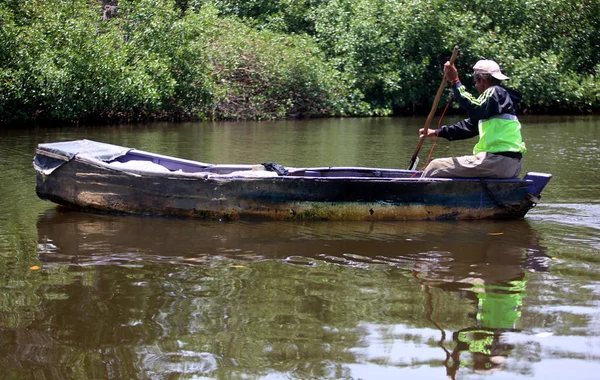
[36,156,535,220]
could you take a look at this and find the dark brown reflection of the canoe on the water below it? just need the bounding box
[37,207,538,268]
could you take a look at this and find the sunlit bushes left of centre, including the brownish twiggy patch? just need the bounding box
[0,0,352,122]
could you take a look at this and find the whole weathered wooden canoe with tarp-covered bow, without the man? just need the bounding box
[34,140,551,220]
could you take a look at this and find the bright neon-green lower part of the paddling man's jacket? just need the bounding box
[473,113,527,155]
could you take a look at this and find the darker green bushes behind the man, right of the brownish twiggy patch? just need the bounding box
[199,0,600,114]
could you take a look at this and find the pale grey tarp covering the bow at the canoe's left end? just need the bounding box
[33,140,132,175]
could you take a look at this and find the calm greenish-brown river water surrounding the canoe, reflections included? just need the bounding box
[0,117,600,379]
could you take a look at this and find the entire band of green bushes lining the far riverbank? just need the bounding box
[0,0,600,123]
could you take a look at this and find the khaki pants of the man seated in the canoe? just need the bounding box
[421,152,521,178]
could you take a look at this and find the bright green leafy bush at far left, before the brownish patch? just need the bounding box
[0,0,184,121]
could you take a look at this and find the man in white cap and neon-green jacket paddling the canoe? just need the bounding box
[419,59,527,178]
